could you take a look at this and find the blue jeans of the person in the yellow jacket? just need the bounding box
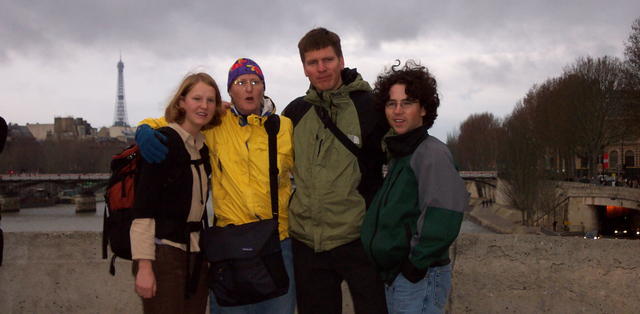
[209,238,296,314]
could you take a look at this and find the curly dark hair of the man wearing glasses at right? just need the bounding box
[373,60,440,129]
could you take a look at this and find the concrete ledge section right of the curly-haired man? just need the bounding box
[450,234,640,313]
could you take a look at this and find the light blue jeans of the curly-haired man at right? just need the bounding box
[385,264,451,314]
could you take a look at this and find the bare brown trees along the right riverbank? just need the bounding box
[447,18,640,225]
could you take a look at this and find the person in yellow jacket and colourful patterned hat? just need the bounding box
[136,58,295,313]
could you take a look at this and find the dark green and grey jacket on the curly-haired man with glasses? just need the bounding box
[362,127,469,282]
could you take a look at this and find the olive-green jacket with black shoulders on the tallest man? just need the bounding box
[282,69,388,252]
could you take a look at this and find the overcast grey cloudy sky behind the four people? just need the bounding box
[0,0,640,140]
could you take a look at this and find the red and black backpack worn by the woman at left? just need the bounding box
[102,145,141,275]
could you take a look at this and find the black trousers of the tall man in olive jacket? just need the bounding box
[292,239,387,314]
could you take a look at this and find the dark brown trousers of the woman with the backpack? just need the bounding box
[133,245,209,314]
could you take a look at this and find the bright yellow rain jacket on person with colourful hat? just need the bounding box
[140,97,293,240]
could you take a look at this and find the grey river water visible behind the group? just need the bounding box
[0,201,493,233]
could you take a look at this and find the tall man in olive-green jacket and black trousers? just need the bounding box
[283,28,388,314]
